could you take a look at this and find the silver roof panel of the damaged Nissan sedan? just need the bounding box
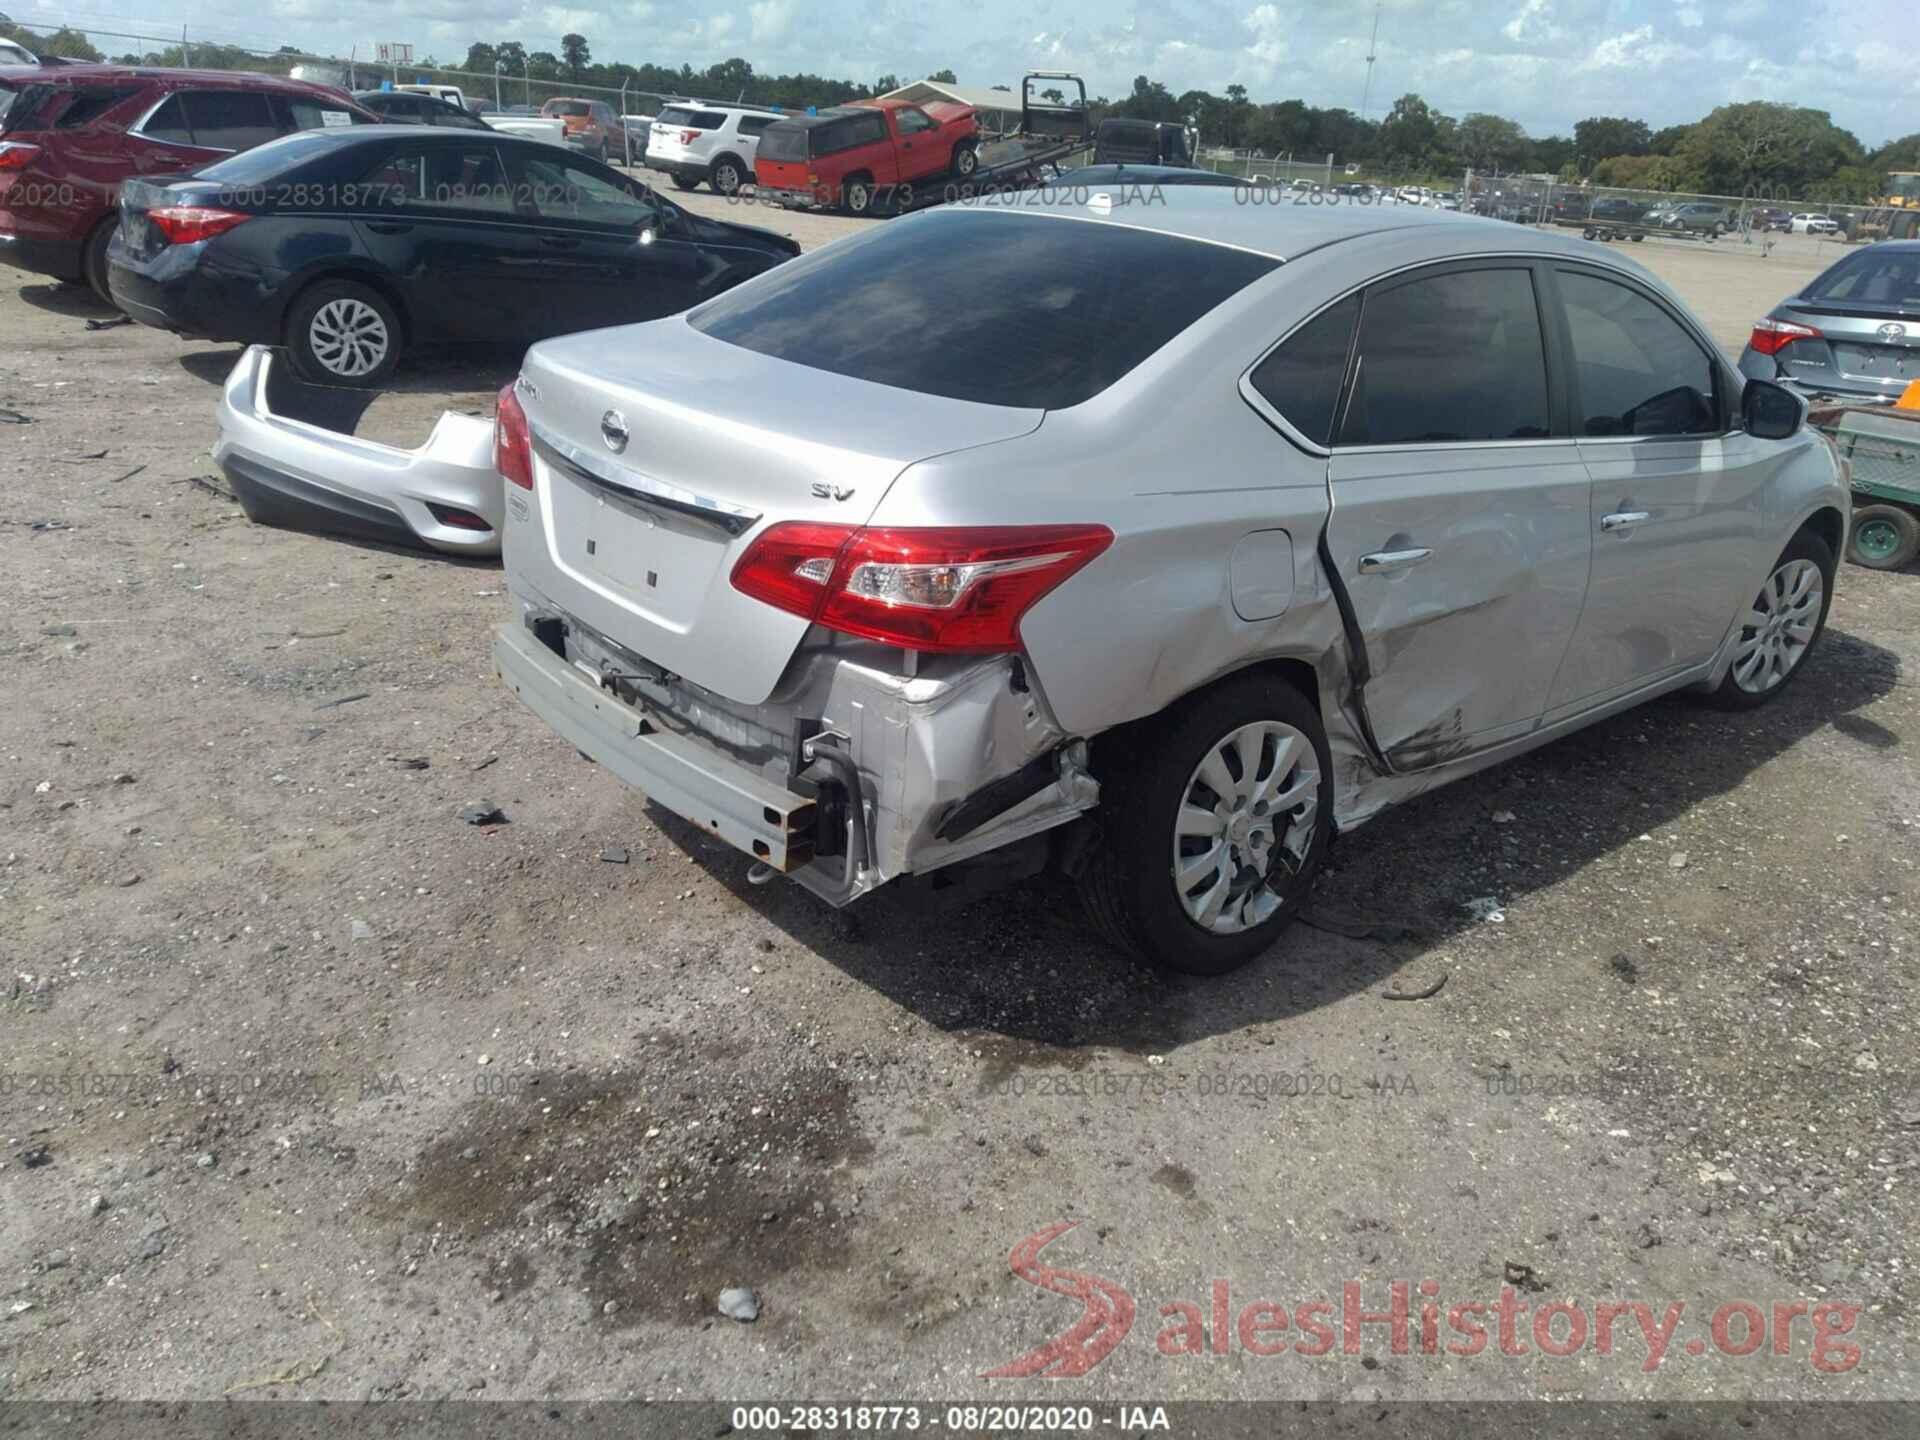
[952,184,1571,261]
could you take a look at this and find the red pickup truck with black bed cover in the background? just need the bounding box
[753,100,979,215]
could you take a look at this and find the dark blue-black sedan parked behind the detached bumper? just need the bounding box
[108,125,801,386]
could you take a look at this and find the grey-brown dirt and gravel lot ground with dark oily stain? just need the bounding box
[0,198,1920,1402]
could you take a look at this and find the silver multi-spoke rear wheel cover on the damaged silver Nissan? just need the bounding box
[1171,720,1321,935]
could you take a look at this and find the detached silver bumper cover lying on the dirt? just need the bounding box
[213,346,505,555]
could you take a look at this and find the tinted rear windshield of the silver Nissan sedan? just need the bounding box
[689,211,1279,409]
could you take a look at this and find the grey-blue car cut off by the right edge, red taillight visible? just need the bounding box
[1740,240,1920,403]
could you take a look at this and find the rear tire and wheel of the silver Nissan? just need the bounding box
[1081,674,1332,975]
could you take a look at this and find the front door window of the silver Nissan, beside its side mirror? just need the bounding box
[1559,271,1720,436]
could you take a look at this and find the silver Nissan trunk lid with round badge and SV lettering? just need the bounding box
[507,317,1044,705]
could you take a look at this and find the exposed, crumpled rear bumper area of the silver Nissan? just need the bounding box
[493,591,1100,906]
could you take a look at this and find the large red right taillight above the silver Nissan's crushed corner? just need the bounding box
[733,520,1114,653]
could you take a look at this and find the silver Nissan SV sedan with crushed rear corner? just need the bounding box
[493,188,1847,973]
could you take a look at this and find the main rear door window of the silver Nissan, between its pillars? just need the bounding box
[1338,267,1551,445]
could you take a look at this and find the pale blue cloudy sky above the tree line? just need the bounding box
[18,0,1920,146]
